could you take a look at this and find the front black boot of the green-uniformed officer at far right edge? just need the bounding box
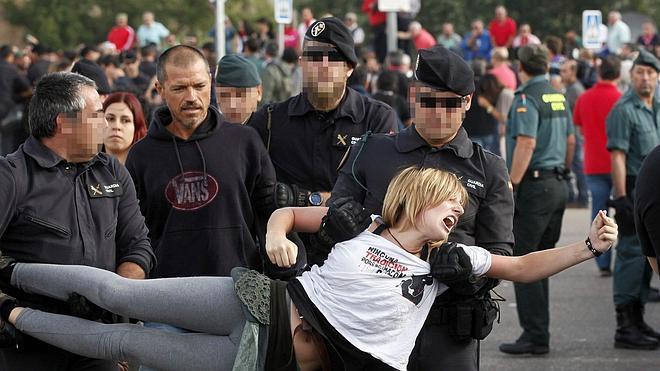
[614,303,658,350]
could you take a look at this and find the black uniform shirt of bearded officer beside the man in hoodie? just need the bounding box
[248,88,397,191]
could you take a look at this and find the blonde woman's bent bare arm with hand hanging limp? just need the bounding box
[266,207,328,268]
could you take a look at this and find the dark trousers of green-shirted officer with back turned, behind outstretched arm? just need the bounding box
[513,175,567,345]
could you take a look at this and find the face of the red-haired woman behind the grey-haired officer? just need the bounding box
[103,102,135,153]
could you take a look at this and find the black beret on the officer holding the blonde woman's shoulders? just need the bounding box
[414,45,474,96]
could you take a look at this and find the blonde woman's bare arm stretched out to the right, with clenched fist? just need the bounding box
[486,211,618,282]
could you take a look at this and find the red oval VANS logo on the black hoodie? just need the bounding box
[165,171,219,211]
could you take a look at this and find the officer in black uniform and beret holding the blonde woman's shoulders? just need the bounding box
[316,46,513,371]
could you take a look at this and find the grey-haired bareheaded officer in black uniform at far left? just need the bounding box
[0,73,156,371]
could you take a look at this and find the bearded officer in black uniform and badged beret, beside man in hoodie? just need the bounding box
[248,17,397,263]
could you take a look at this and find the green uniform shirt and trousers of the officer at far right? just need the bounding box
[606,90,660,305]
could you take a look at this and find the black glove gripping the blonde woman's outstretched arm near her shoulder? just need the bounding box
[429,242,472,288]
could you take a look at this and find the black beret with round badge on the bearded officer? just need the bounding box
[305,17,358,67]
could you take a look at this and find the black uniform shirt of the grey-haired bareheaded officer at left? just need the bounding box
[0,137,155,273]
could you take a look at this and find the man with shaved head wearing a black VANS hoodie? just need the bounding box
[126,45,275,278]
